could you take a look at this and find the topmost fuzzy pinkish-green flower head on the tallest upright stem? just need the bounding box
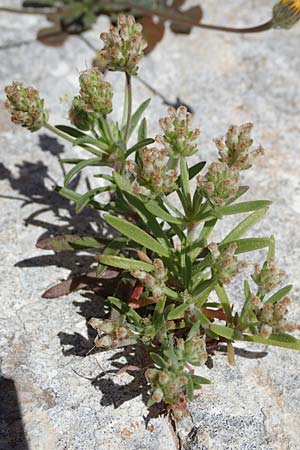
[99,14,147,75]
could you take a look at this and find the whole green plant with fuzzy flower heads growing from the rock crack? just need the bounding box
[6,16,300,419]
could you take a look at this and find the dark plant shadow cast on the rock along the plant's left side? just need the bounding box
[0,135,268,416]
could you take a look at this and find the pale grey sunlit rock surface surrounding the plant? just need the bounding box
[0,0,300,450]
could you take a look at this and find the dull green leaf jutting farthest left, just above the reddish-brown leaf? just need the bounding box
[36,235,104,251]
